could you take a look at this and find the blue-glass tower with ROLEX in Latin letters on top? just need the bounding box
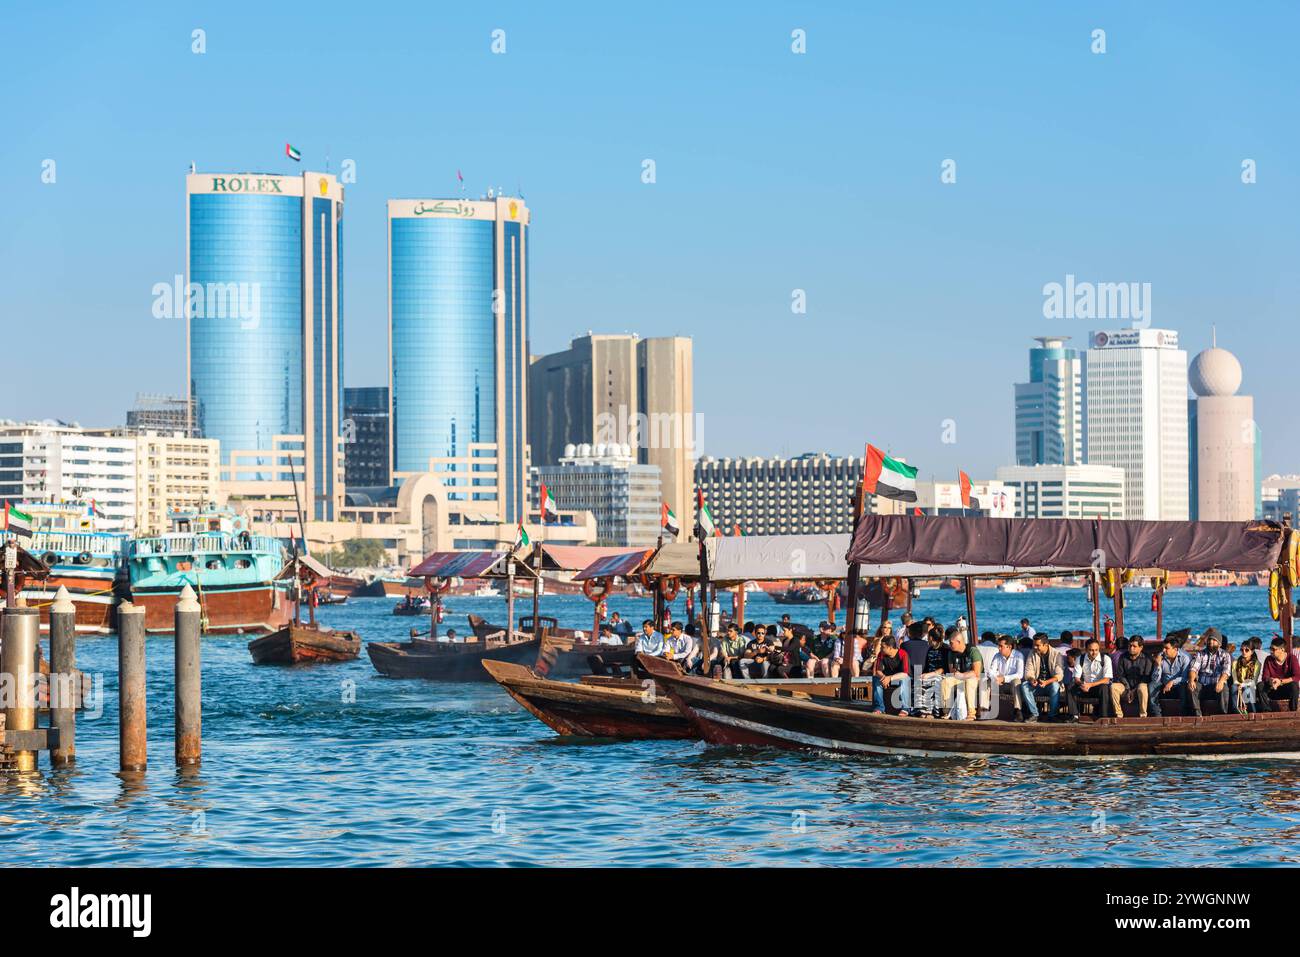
[185,167,343,520]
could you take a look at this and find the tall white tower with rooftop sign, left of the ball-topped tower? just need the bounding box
[1083,329,1188,521]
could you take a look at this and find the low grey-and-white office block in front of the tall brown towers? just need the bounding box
[532,445,663,546]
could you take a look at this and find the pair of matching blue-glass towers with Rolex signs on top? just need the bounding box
[186,173,529,524]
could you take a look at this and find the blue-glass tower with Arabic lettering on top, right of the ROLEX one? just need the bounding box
[389,196,529,523]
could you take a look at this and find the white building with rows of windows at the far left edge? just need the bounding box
[0,420,135,531]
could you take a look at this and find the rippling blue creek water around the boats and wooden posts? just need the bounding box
[0,588,1300,866]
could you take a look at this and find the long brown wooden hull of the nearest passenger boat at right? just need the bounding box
[640,657,1300,758]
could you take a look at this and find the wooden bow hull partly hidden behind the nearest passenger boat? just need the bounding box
[482,661,698,740]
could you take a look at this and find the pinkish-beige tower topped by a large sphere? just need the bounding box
[1188,335,1258,521]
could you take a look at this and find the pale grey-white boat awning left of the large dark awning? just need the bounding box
[712,533,849,585]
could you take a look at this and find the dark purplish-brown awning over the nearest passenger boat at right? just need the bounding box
[848,515,1282,577]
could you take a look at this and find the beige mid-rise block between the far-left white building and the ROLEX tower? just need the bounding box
[135,430,221,534]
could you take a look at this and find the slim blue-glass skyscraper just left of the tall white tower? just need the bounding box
[1015,335,1083,465]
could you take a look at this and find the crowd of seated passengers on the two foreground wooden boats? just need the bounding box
[624,615,1300,722]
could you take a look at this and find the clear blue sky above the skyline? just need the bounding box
[0,1,1300,477]
